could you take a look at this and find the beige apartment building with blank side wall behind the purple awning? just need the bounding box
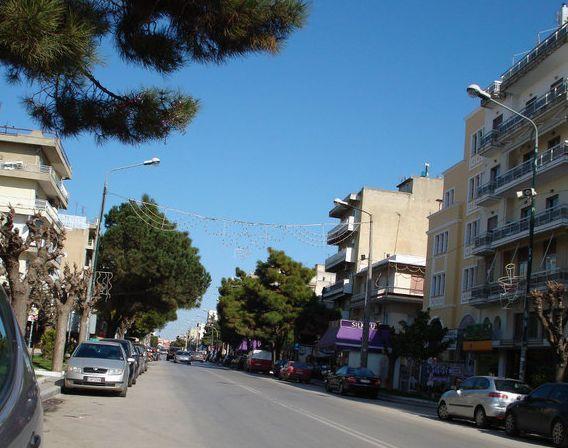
[322,172,443,377]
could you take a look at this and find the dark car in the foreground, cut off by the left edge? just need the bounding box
[0,288,43,448]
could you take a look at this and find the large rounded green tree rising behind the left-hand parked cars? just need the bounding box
[97,195,211,336]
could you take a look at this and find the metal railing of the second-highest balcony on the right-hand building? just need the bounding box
[479,81,568,154]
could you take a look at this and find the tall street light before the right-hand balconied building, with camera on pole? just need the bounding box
[467,84,538,381]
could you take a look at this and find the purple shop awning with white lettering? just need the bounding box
[318,319,390,351]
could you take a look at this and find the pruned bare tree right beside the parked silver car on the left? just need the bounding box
[46,264,89,371]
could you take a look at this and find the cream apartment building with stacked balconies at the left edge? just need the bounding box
[0,127,71,271]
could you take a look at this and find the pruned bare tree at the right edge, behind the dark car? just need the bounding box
[531,281,568,382]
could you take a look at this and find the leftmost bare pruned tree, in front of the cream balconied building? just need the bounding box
[0,207,65,331]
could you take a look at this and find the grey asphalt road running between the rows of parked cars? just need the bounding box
[44,361,547,448]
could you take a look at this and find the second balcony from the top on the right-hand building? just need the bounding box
[479,81,568,157]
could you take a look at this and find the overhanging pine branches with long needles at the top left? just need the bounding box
[0,0,307,143]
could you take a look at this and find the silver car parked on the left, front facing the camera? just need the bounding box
[63,341,130,397]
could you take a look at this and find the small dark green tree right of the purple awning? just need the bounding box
[387,309,450,387]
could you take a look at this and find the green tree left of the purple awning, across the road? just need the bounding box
[217,248,314,359]
